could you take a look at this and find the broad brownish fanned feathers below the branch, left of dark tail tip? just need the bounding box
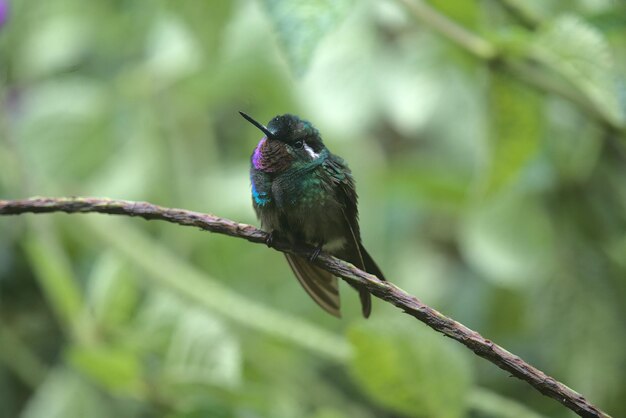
[285,254,341,318]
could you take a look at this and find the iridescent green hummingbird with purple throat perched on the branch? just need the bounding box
[239,112,385,318]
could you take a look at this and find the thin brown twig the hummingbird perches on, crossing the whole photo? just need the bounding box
[0,197,609,418]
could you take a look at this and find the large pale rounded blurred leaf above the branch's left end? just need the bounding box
[15,76,111,183]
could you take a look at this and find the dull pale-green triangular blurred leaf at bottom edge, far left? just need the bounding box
[20,367,113,418]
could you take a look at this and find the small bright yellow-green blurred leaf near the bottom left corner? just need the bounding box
[66,346,142,396]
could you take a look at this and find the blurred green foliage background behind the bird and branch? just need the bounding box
[0,0,626,418]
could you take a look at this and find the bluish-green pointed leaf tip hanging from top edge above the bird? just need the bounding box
[263,0,353,75]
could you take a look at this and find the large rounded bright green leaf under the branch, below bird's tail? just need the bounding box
[348,321,472,418]
